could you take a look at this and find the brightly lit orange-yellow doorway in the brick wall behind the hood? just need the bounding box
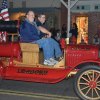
[76,16,88,44]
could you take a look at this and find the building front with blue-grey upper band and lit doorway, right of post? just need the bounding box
[71,0,100,43]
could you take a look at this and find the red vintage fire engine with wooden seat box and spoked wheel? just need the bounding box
[0,20,100,100]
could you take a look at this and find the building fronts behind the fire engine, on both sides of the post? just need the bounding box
[0,0,100,43]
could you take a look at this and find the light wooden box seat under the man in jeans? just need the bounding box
[20,43,39,65]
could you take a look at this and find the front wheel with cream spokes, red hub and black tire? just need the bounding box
[74,65,100,100]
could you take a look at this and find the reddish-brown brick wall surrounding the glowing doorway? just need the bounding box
[61,12,100,44]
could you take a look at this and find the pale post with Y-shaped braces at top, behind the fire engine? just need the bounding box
[60,0,78,44]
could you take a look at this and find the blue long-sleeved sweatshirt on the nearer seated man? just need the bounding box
[19,20,40,42]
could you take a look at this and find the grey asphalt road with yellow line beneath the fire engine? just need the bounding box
[0,78,79,100]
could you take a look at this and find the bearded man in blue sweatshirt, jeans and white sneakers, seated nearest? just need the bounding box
[19,11,62,65]
